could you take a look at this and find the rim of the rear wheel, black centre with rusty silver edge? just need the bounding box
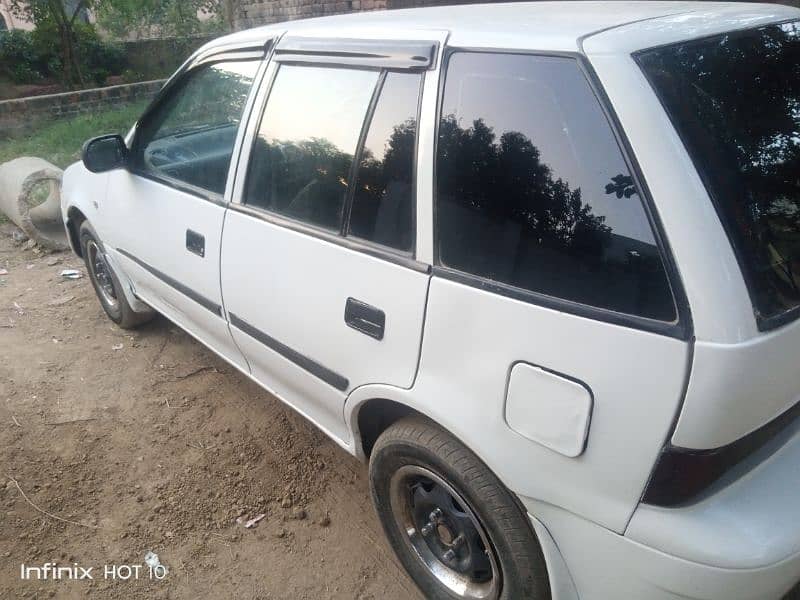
[389,465,501,600]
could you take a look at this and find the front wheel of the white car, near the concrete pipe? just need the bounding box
[79,221,155,329]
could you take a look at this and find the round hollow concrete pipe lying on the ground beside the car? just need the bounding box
[0,156,69,250]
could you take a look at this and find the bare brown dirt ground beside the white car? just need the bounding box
[0,224,419,599]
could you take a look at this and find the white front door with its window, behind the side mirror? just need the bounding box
[104,47,264,369]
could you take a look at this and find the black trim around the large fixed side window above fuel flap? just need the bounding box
[432,46,694,341]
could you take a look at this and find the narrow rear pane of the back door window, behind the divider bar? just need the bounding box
[350,73,422,250]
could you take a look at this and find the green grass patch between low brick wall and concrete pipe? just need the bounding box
[0,102,147,169]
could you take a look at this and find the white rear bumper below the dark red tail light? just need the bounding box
[523,423,800,600]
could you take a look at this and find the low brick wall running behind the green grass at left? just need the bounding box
[0,80,164,138]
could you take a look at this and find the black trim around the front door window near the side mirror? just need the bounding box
[128,38,275,208]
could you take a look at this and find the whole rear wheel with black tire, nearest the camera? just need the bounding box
[369,416,550,600]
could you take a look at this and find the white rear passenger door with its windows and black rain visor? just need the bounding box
[222,37,435,443]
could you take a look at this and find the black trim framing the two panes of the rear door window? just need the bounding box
[234,56,428,273]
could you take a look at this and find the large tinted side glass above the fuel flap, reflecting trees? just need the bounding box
[437,53,675,321]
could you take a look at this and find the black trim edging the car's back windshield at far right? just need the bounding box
[631,16,800,332]
